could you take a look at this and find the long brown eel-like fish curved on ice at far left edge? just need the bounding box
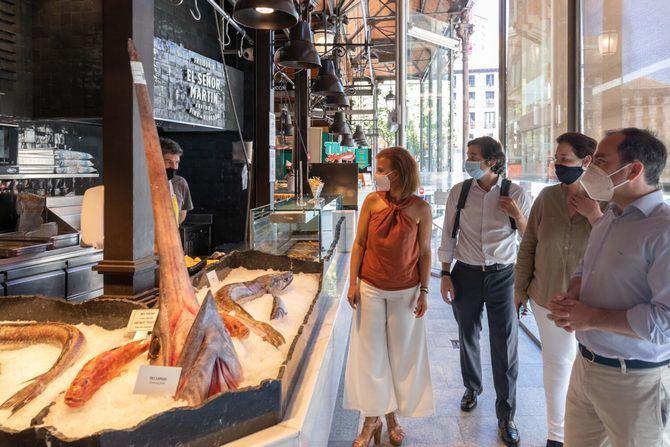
[0,323,86,414]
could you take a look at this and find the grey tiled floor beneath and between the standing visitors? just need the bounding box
[328,278,547,447]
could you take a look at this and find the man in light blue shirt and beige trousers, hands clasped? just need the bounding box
[549,128,670,447]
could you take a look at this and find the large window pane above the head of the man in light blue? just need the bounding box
[581,0,670,188]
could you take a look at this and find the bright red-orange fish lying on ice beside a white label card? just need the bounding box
[65,340,149,408]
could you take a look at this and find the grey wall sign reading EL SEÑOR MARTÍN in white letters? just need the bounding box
[154,38,244,130]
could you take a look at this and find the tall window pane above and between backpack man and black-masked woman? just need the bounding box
[506,0,568,181]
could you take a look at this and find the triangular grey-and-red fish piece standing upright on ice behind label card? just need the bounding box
[175,293,242,405]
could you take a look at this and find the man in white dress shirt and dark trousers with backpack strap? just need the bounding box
[438,137,531,445]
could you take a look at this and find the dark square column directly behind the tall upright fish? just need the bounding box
[96,0,156,299]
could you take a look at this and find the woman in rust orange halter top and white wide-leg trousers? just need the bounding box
[344,148,434,447]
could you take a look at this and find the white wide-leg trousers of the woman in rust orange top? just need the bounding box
[344,282,435,417]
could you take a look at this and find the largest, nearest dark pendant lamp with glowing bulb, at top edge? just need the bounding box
[233,0,300,30]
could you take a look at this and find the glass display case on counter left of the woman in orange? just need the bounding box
[250,195,342,262]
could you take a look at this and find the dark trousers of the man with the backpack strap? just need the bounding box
[451,263,519,420]
